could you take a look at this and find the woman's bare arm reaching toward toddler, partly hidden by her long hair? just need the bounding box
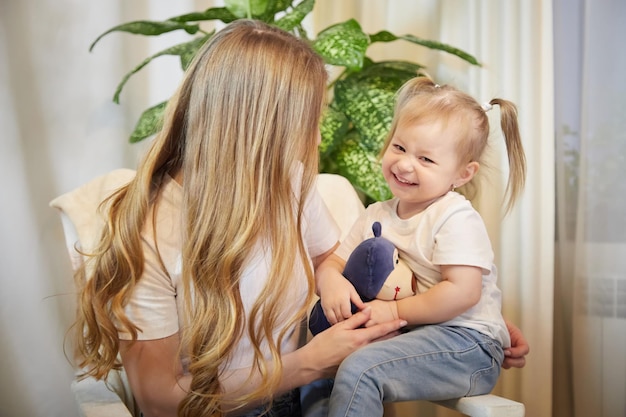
[120,309,406,417]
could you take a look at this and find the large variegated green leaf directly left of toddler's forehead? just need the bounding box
[334,61,420,154]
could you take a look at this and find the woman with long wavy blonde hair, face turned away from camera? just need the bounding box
[76,20,404,417]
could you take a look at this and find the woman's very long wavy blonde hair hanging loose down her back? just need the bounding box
[76,20,327,416]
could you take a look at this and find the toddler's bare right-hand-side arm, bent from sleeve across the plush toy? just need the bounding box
[367,265,482,326]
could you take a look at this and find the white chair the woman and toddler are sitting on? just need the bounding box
[50,169,525,417]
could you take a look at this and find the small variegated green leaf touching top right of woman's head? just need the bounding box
[313,19,370,71]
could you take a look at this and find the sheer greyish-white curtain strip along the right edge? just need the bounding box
[554,0,626,417]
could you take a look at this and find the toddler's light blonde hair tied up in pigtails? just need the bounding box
[381,76,526,213]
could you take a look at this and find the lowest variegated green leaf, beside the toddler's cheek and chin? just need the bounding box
[335,130,391,201]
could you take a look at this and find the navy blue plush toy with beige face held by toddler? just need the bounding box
[309,222,415,335]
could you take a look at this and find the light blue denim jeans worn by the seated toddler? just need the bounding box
[301,325,504,417]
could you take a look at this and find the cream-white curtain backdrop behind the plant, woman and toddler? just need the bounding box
[0,0,552,417]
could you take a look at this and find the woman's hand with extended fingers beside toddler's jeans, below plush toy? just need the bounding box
[301,307,406,379]
